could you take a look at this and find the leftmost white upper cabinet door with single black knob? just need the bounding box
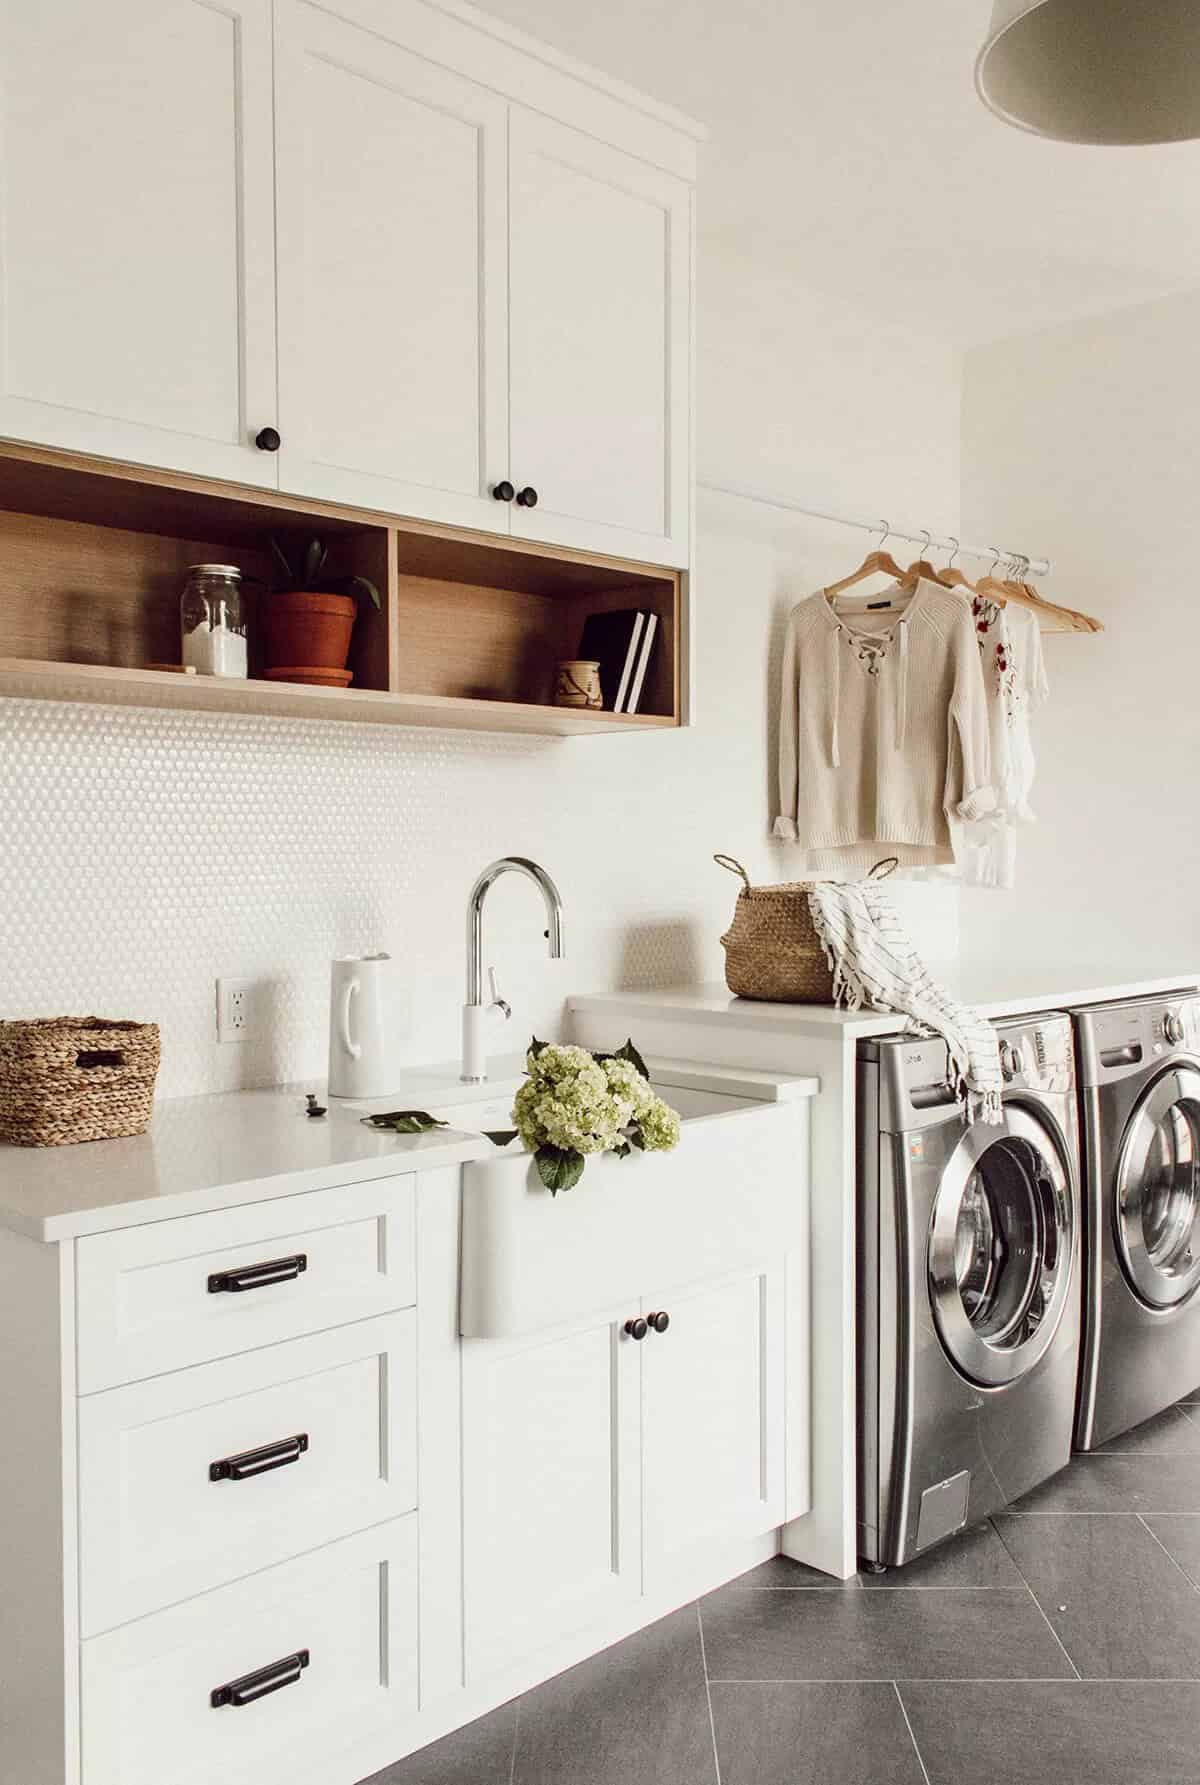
[0,0,275,486]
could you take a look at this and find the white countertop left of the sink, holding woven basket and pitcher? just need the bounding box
[0,1062,500,1241]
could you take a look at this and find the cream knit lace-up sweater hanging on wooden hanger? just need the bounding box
[775,580,995,878]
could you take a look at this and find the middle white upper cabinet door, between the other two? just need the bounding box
[277,0,509,532]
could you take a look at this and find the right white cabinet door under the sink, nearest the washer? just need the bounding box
[641,1264,786,1589]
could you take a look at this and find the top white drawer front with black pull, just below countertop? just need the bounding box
[79,1175,416,1394]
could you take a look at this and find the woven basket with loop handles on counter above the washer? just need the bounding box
[713,855,900,1005]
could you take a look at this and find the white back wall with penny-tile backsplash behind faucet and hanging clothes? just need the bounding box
[0,245,959,1094]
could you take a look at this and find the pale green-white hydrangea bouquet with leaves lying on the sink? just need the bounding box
[493,1037,679,1196]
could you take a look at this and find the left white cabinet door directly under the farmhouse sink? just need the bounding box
[463,1308,641,1683]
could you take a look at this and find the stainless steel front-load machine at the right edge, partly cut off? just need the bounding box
[1075,992,1200,1449]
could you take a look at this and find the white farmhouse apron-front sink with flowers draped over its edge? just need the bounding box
[441,1066,816,1339]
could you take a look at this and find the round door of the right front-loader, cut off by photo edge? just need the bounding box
[1114,1067,1200,1308]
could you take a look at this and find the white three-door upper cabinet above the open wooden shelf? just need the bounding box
[0,0,695,566]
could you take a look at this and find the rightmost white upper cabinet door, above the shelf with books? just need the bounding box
[509,107,691,564]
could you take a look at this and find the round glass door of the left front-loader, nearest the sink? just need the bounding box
[929,1107,1075,1387]
